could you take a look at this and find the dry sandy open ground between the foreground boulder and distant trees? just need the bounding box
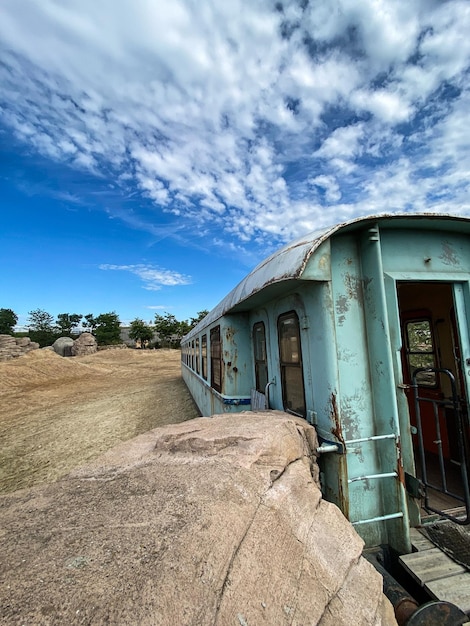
[0,349,198,493]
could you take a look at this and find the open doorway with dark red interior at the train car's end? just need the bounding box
[398,281,470,523]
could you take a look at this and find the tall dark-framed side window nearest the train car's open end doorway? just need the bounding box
[278,312,306,417]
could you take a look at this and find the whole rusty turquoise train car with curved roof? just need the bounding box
[182,214,470,620]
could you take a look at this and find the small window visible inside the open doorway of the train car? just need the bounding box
[405,319,437,387]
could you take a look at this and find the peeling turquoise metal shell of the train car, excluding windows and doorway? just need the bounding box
[185,208,470,553]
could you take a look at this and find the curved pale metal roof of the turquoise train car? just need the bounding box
[183,213,470,340]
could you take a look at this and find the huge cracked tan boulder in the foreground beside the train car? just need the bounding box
[0,411,396,626]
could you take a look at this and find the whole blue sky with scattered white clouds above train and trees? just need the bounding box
[0,0,470,324]
